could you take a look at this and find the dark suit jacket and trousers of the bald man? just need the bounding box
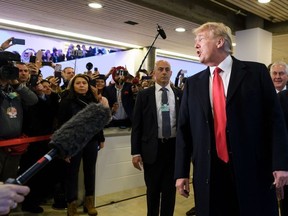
[131,86,181,216]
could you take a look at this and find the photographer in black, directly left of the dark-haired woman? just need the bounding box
[19,77,60,213]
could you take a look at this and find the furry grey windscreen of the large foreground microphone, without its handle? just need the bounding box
[49,103,111,158]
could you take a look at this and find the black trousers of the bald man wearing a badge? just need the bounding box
[144,139,176,216]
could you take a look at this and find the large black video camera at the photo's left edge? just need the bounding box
[0,51,20,80]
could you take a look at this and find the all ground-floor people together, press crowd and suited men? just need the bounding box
[0,22,288,216]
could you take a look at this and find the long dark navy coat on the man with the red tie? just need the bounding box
[175,58,288,216]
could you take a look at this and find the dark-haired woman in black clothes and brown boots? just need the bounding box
[58,74,105,216]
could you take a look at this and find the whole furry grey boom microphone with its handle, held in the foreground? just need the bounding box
[5,103,111,185]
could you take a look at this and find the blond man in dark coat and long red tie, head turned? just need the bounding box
[175,23,288,216]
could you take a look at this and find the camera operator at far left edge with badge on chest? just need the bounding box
[0,51,38,181]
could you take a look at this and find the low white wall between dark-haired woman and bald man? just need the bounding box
[95,128,144,197]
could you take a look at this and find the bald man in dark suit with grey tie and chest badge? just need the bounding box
[131,60,181,216]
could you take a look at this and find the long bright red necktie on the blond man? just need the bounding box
[212,67,229,163]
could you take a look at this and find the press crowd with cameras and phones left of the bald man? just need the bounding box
[0,39,156,216]
